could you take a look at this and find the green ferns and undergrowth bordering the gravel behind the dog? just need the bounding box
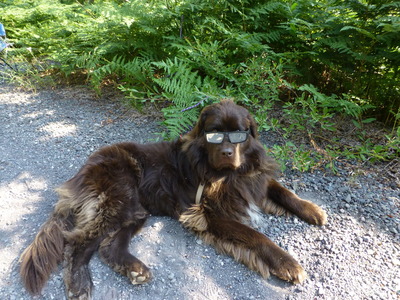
[0,0,400,170]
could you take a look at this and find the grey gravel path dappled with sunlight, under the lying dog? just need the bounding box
[0,84,400,300]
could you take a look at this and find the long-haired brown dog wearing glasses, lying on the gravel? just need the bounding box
[21,100,326,299]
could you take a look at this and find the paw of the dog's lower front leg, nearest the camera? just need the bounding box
[271,257,307,284]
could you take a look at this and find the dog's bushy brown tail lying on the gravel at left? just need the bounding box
[20,215,64,295]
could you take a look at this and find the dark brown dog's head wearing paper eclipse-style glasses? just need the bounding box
[183,100,265,173]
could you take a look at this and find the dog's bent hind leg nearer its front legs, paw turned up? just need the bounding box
[99,218,151,284]
